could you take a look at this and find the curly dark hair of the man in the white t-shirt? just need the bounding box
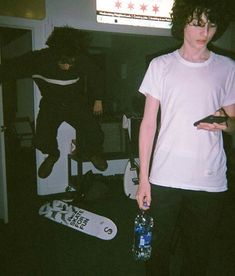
[171,0,234,41]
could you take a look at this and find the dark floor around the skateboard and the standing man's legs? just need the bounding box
[0,148,235,276]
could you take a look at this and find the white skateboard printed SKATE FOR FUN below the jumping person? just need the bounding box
[39,200,117,240]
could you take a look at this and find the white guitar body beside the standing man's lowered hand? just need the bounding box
[124,158,139,199]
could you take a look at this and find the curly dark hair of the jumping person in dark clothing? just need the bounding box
[46,26,91,57]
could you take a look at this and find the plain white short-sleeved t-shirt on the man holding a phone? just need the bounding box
[139,50,235,192]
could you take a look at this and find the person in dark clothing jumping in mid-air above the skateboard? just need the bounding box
[0,26,108,178]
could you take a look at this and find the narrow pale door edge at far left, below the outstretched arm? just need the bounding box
[0,84,8,223]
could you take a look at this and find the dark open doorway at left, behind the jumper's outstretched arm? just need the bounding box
[0,27,36,221]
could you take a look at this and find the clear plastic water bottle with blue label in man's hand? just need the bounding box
[132,210,153,261]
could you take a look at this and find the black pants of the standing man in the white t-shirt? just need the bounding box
[146,185,225,276]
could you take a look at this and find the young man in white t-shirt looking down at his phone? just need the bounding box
[136,0,235,276]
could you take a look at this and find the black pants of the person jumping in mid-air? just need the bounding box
[34,99,104,157]
